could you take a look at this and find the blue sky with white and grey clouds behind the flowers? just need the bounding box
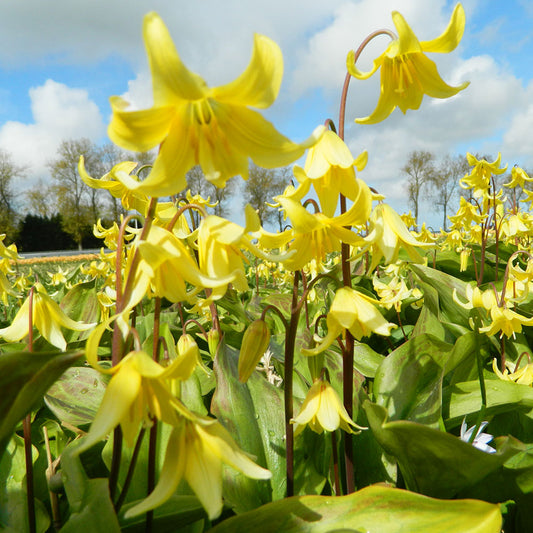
[0,0,533,225]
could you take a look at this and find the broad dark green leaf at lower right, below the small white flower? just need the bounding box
[363,401,523,498]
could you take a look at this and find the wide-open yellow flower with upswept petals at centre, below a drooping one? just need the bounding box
[258,188,372,271]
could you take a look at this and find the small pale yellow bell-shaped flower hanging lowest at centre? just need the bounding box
[291,379,366,436]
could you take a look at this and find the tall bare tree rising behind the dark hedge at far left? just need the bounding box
[48,138,102,250]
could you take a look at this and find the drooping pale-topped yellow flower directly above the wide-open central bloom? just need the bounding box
[288,130,368,217]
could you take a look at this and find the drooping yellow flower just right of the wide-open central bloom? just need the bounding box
[364,204,434,272]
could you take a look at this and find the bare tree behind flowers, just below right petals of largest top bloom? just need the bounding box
[244,163,292,231]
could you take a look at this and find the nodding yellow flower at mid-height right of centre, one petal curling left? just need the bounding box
[302,287,396,355]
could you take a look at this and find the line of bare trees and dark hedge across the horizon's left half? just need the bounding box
[0,138,292,252]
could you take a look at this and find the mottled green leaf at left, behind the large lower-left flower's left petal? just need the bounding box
[44,367,109,426]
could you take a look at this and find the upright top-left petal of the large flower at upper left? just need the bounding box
[143,12,208,106]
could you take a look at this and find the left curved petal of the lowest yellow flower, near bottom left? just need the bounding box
[124,426,187,518]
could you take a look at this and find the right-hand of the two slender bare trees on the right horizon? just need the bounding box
[430,155,470,231]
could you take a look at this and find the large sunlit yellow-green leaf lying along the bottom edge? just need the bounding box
[210,486,502,533]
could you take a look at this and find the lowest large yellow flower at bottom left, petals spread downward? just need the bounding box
[125,417,272,520]
